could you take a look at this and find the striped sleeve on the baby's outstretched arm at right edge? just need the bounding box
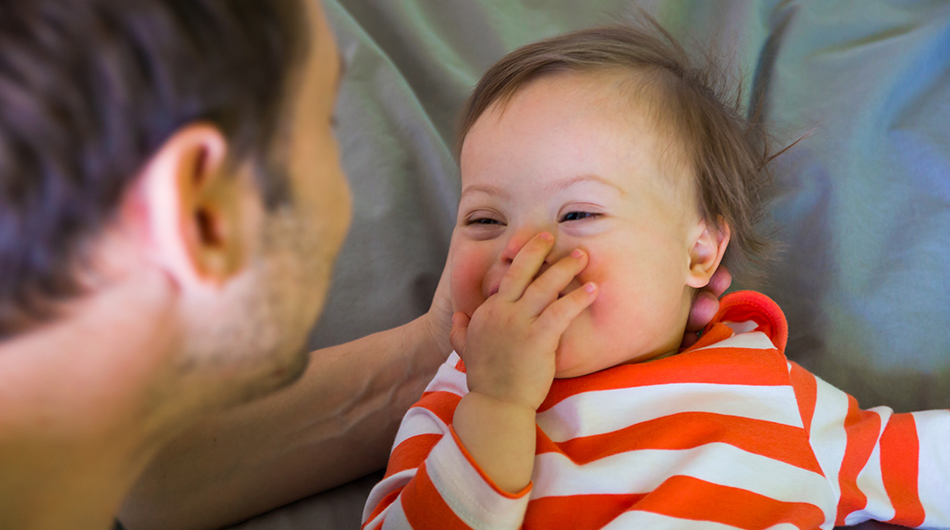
[791,363,950,528]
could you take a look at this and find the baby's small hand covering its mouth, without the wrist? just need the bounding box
[450,232,597,410]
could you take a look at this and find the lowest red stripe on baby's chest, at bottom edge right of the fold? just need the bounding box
[634,476,825,530]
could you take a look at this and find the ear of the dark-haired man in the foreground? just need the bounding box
[138,123,254,286]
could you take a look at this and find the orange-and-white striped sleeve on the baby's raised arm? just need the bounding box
[362,354,530,530]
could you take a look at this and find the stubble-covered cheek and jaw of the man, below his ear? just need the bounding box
[180,206,335,406]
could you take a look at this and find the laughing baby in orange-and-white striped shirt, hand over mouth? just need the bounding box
[363,21,950,530]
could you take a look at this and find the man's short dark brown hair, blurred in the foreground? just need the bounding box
[0,0,308,338]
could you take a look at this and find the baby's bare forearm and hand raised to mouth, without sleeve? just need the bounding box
[451,233,597,493]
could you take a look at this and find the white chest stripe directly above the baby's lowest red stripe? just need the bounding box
[532,443,835,506]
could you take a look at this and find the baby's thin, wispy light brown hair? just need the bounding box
[457,21,780,276]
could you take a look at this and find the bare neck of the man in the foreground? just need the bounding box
[0,273,179,529]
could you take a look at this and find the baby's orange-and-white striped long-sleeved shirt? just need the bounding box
[363,291,950,530]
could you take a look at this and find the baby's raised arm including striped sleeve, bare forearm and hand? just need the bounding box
[363,235,596,529]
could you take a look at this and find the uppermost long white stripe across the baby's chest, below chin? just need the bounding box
[537,383,803,442]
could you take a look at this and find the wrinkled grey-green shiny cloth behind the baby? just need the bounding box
[234,0,950,530]
